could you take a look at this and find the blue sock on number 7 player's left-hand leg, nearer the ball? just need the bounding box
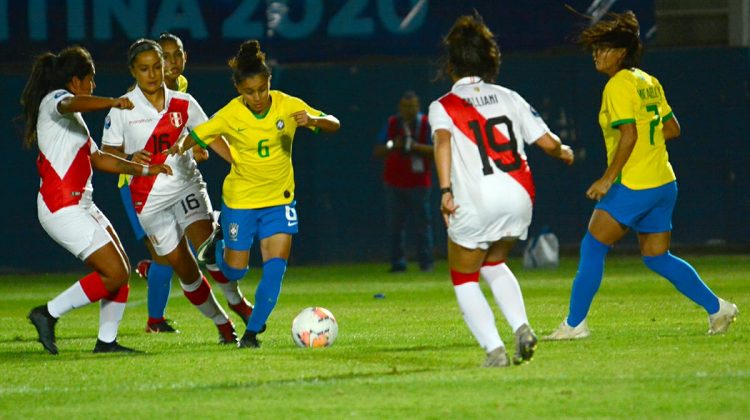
[567,231,610,327]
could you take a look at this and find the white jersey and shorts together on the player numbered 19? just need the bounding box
[429,77,549,249]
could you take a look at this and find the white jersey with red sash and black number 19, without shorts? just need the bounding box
[429,77,549,204]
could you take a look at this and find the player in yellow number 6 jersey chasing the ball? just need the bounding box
[168,40,340,347]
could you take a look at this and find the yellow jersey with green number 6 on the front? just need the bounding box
[190,90,324,209]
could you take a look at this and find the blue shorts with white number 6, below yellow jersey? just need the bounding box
[221,201,299,251]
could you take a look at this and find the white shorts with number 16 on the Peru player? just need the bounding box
[138,184,213,255]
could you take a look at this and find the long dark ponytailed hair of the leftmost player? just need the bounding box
[21,45,94,148]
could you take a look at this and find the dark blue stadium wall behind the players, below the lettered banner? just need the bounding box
[0,48,750,272]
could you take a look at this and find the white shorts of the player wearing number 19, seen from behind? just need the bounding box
[448,177,533,249]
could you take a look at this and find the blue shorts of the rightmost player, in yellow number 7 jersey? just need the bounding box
[595,181,677,233]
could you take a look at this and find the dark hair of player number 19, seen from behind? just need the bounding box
[438,13,500,83]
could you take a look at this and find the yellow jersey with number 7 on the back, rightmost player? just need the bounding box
[599,68,675,190]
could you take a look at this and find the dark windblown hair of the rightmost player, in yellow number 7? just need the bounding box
[577,10,643,69]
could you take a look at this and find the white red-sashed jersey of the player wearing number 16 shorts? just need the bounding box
[102,86,208,213]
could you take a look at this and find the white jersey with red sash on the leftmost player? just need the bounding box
[36,89,99,221]
